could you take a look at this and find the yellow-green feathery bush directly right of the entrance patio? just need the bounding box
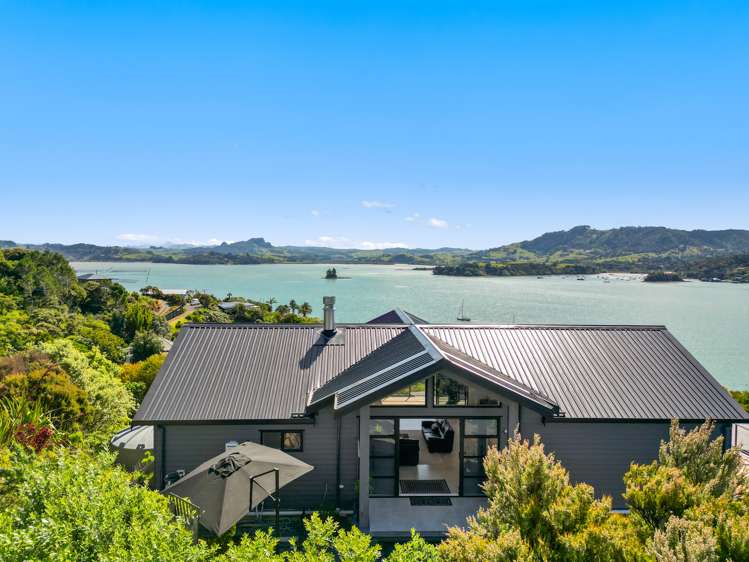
[440,435,637,560]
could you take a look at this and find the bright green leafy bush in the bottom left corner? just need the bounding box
[0,449,211,562]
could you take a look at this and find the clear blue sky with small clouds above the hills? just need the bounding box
[0,0,749,248]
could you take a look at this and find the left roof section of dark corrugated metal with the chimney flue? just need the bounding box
[134,324,407,424]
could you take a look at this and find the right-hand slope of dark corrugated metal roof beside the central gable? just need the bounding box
[419,325,749,420]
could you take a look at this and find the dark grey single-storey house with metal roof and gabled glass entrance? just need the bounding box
[134,297,747,536]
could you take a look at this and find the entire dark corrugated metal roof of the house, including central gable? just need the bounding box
[134,322,749,424]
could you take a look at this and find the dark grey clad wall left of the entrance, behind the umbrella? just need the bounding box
[164,402,358,510]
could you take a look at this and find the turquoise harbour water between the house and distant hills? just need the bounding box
[72,262,749,389]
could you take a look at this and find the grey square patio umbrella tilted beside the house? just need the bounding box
[164,442,314,536]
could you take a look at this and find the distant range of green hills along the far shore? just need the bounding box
[8,226,749,280]
